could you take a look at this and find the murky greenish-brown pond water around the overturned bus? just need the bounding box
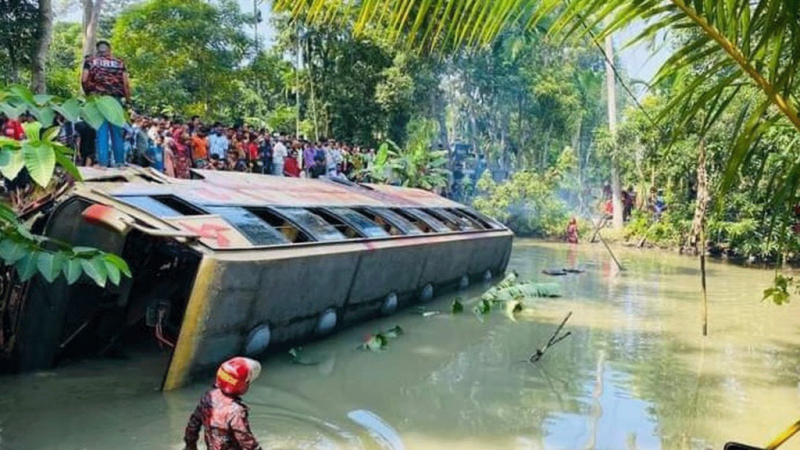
[0,241,800,450]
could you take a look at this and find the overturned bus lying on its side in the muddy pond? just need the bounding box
[0,169,512,390]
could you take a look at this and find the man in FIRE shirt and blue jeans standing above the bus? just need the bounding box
[81,40,131,167]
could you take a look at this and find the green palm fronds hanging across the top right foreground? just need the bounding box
[275,0,800,197]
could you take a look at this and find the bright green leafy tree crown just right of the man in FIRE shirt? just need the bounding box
[113,0,252,119]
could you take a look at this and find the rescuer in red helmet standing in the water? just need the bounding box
[183,357,261,450]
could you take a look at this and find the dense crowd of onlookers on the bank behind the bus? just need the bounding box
[57,112,375,180]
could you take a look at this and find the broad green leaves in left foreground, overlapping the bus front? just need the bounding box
[0,86,131,286]
